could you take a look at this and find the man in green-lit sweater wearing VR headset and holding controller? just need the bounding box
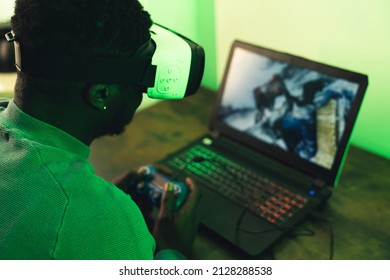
[0,0,199,259]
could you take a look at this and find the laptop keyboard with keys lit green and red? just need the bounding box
[167,145,307,226]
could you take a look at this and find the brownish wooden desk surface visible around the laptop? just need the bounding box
[90,89,390,260]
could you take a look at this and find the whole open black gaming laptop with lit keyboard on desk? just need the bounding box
[157,41,368,257]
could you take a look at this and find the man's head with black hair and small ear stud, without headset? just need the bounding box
[11,0,152,140]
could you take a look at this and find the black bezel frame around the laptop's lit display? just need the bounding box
[209,40,368,186]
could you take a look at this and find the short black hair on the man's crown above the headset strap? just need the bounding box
[11,0,152,56]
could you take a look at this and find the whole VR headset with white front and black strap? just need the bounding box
[5,24,205,99]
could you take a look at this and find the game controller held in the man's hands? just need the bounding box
[137,165,188,211]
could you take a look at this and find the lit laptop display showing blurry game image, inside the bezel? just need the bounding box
[219,47,358,168]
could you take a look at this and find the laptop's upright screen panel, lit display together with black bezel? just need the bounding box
[215,41,367,184]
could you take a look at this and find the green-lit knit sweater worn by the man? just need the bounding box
[0,100,155,260]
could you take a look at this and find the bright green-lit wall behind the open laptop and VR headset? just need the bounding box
[141,0,390,158]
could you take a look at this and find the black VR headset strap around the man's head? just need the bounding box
[6,31,156,87]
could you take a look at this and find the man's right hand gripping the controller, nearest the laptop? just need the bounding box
[153,178,200,255]
